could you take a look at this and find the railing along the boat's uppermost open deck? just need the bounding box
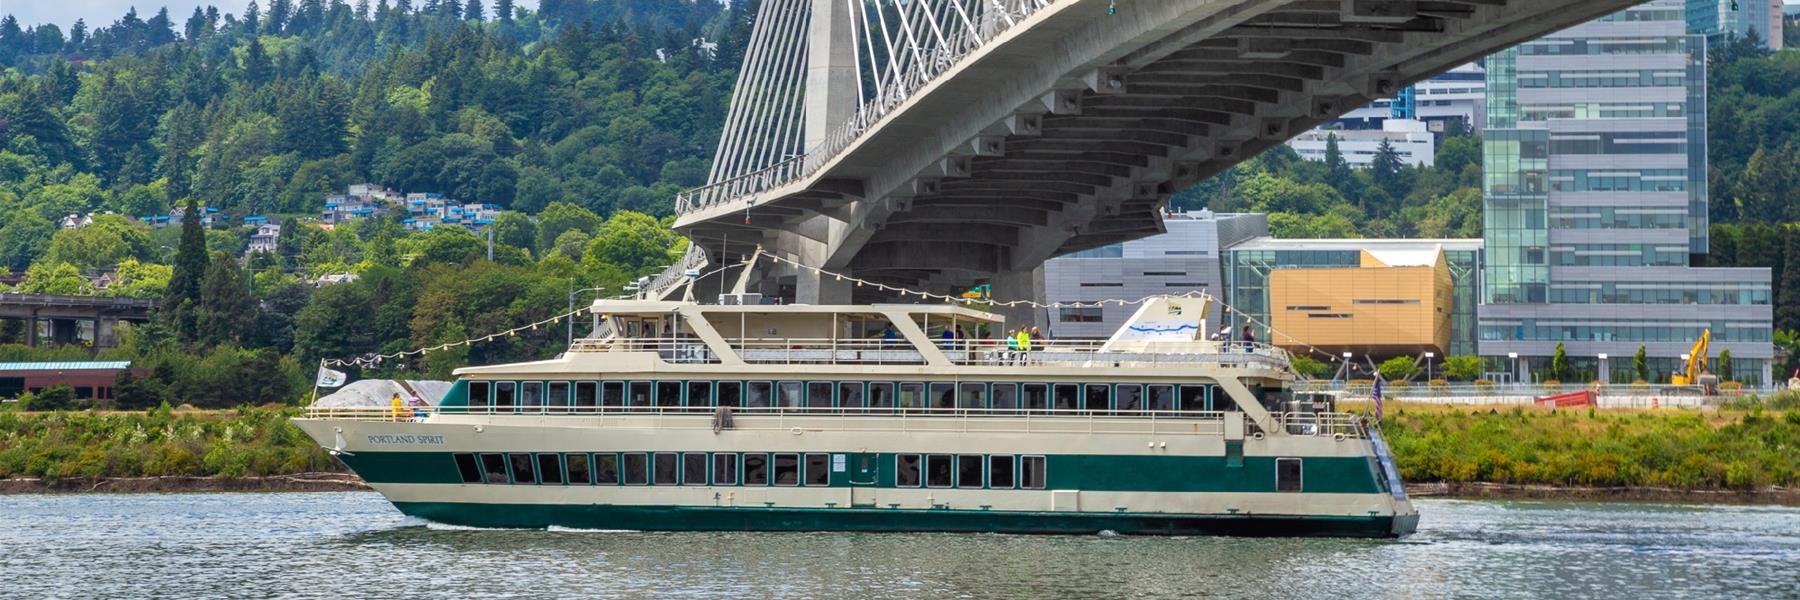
[572,337,1289,369]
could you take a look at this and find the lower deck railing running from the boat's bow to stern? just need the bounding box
[306,407,1364,438]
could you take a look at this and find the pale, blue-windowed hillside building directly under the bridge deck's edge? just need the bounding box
[1332,63,1487,133]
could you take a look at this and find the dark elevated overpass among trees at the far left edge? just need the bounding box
[0,294,157,350]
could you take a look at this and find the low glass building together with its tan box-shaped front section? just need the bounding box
[1224,238,1481,360]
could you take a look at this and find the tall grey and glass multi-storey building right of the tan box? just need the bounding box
[1480,0,1775,384]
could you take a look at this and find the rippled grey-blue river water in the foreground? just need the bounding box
[0,494,1800,598]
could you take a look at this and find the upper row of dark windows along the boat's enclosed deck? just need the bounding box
[468,380,1237,413]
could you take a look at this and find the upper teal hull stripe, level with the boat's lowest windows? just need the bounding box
[338,452,1384,494]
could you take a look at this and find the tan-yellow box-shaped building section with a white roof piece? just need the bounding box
[1269,245,1454,357]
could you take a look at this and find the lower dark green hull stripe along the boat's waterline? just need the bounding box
[394,503,1395,537]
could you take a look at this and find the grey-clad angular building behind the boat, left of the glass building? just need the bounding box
[1044,211,1269,339]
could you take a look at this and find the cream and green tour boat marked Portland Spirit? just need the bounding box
[295,297,1418,537]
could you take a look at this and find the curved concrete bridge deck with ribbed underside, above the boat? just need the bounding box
[677,0,1634,303]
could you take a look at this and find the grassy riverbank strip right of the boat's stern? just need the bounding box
[1381,404,1800,490]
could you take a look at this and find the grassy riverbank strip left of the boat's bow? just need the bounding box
[0,401,342,481]
